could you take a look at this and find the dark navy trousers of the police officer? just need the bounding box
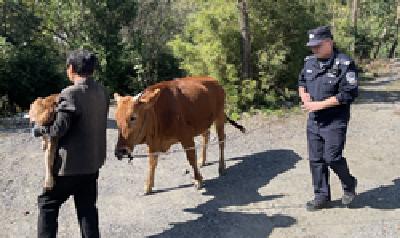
[307,120,355,201]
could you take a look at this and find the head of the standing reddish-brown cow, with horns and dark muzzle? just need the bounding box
[114,88,160,159]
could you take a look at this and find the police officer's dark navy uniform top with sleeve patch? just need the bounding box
[299,50,358,125]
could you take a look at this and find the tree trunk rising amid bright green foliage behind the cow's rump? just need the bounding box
[238,0,251,79]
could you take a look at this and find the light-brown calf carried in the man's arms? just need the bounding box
[29,94,58,189]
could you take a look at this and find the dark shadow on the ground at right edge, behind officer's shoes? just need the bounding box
[349,178,400,210]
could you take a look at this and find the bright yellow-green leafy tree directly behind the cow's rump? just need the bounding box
[169,0,317,112]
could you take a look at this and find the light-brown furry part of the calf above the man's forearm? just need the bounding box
[29,94,58,125]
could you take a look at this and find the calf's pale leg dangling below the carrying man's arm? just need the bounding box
[44,137,58,189]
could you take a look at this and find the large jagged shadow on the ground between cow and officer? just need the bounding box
[150,150,301,238]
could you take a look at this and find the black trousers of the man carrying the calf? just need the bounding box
[38,172,100,238]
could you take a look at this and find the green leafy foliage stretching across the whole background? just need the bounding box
[0,0,400,115]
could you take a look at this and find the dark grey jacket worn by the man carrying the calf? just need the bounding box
[49,78,109,176]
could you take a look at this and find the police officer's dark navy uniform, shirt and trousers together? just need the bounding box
[299,49,358,201]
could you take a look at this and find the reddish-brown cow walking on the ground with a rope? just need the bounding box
[114,77,245,194]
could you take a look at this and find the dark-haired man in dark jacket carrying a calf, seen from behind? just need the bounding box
[34,50,109,237]
